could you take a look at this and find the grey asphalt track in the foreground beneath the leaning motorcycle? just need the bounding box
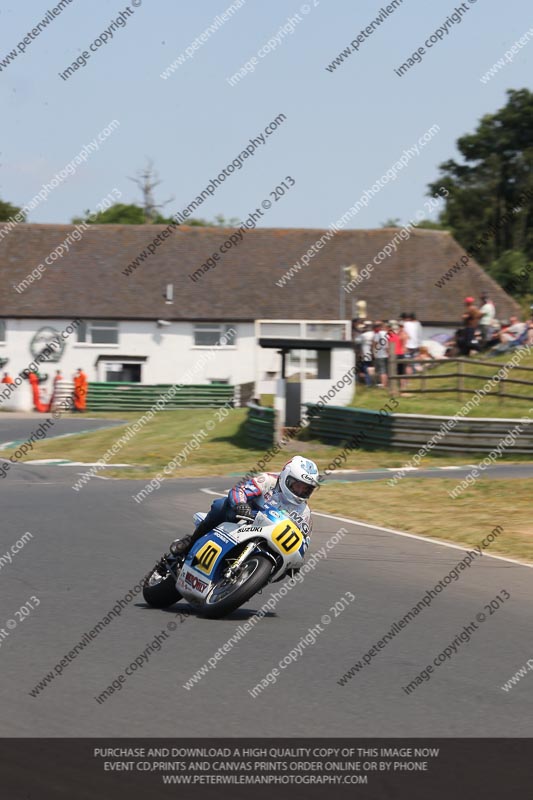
[0,465,533,737]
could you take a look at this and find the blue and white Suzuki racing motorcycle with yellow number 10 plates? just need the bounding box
[143,503,309,619]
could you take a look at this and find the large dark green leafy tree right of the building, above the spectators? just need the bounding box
[429,89,533,279]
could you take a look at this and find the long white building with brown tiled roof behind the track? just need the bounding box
[0,224,518,404]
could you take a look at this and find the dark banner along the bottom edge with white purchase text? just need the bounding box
[0,738,533,800]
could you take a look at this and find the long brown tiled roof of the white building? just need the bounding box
[0,224,519,323]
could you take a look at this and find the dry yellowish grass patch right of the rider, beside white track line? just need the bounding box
[312,478,533,563]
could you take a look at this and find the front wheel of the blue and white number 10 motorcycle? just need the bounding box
[204,555,272,619]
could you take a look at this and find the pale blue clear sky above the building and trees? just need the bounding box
[0,0,533,228]
